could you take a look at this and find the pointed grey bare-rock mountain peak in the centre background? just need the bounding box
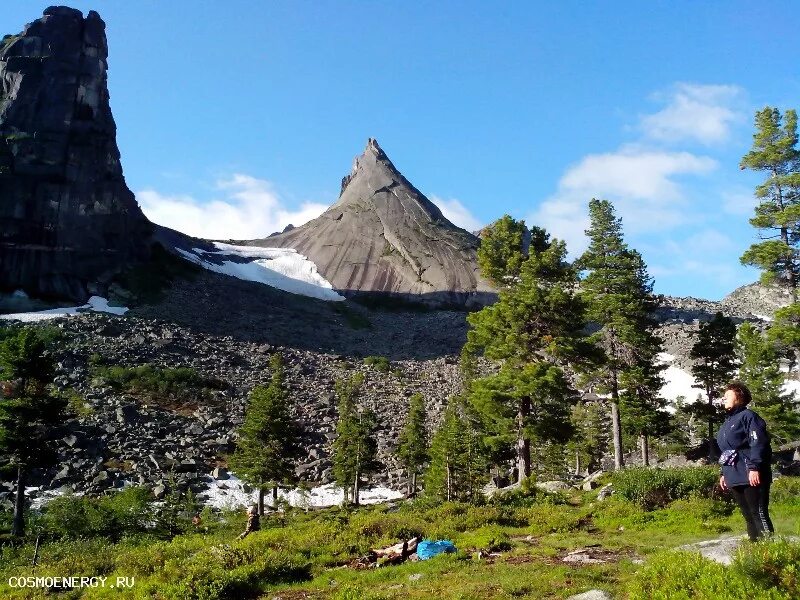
[249,139,492,305]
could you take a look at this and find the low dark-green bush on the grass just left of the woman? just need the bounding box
[612,467,719,510]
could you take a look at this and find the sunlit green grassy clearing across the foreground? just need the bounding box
[0,478,800,600]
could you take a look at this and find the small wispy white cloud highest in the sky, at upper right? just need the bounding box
[639,83,744,144]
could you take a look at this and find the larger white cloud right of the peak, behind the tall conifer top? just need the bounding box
[528,145,717,255]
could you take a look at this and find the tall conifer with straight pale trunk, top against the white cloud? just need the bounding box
[578,198,663,469]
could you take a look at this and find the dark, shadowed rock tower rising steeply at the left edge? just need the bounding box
[0,7,150,301]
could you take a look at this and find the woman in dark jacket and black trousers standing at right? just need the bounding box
[717,381,774,541]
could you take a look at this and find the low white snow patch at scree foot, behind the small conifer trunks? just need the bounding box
[197,474,403,509]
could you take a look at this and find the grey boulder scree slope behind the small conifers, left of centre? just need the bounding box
[0,314,461,502]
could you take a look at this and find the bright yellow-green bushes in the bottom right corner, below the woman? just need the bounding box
[628,540,800,600]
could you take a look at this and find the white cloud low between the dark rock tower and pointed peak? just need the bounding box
[136,174,327,240]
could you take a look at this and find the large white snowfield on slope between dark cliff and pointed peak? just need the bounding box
[177,242,344,302]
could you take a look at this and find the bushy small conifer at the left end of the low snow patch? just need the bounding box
[229,354,301,514]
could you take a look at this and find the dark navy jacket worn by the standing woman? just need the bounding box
[717,406,772,486]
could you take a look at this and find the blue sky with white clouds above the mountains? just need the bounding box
[6,0,800,299]
